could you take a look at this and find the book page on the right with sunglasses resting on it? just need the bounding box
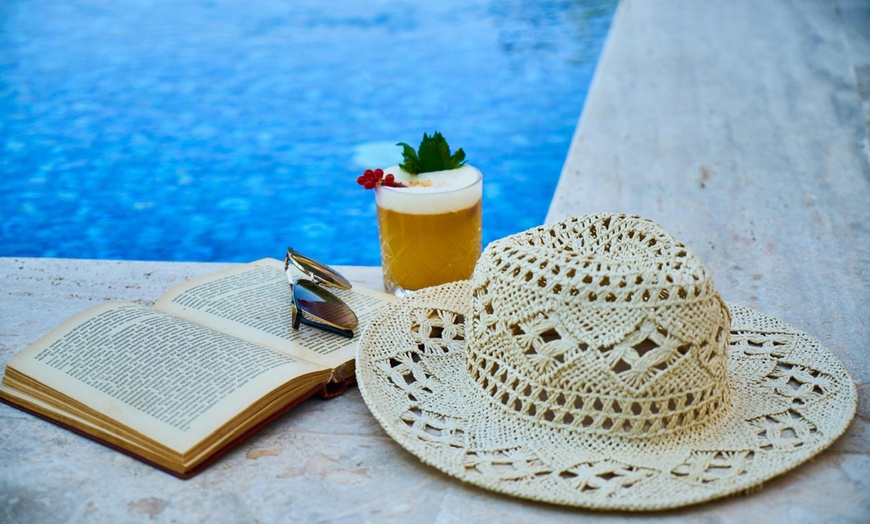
[154,258,395,368]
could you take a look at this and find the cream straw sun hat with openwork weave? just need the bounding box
[356,214,857,510]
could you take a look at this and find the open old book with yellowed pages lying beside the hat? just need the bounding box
[0,259,392,478]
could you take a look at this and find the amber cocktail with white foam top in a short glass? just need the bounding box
[377,165,483,294]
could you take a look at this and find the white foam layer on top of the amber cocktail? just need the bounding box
[377,164,482,215]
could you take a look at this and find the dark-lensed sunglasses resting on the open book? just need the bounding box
[284,247,359,338]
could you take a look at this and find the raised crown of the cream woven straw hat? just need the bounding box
[466,214,731,438]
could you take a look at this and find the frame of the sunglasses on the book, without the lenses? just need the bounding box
[284,247,359,338]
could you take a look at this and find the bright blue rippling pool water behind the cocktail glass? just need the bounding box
[0,0,616,265]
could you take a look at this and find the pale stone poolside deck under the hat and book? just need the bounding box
[0,0,870,522]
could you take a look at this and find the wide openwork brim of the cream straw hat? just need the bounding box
[356,281,857,511]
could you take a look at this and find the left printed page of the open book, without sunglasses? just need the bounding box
[1,302,328,453]
